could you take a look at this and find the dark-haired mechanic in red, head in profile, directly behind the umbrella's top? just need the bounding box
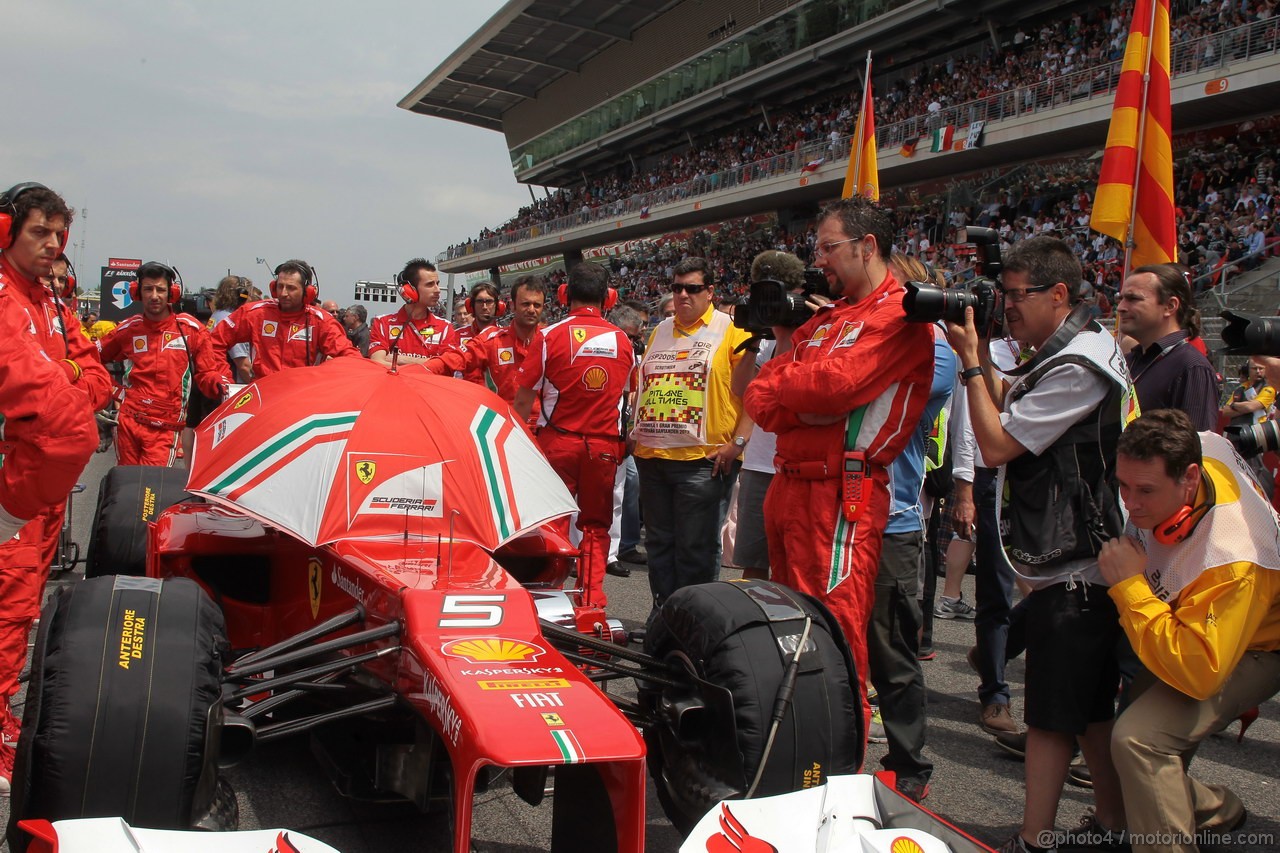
[369,257,458,365]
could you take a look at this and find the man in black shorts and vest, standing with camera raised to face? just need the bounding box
[947,237,1130,853]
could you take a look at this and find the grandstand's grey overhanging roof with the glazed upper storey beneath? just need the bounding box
[398,0,1039,186]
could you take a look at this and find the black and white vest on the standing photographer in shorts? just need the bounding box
[996,306,1138,580]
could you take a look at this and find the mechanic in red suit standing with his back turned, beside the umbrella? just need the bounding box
[515,261,635,607]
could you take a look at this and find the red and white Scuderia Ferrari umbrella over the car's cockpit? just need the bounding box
[187,359,577,549]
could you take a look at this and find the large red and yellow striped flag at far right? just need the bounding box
[1089,0,1178,273]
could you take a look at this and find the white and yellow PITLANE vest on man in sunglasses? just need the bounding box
[631,311,732,447]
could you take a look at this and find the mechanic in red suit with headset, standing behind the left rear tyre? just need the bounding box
[97,261,230,466]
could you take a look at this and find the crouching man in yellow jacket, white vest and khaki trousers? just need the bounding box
[1098,409,1280,852]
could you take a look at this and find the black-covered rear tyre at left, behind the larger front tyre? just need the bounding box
[84,465,191,578]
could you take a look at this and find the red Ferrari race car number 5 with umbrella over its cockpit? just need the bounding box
[9,359,986,853]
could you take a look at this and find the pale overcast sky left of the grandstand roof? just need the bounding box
[0,0,529,304]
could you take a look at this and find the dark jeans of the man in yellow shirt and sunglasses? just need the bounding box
[636,459,741,607]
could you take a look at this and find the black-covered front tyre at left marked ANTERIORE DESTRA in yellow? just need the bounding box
[9,576,234,850]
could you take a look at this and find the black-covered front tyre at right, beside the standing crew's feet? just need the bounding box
[640,580,863,835]
